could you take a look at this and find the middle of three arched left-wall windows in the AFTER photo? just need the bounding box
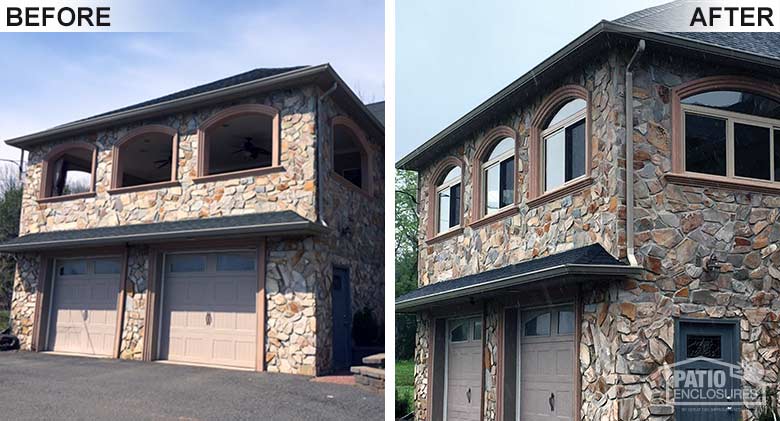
[480,137,515,216]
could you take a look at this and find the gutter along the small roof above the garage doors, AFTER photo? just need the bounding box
[395,264,644,313]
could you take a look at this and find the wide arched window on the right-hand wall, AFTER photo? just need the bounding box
[680,89,780,181]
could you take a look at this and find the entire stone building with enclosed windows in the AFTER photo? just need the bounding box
[396,2,780,421]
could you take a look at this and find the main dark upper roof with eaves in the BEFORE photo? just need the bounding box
[5,64,384,149]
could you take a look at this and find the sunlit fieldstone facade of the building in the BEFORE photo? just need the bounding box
[7,80,384,375]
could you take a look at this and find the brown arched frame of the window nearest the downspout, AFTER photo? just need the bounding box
[527,85,593,208]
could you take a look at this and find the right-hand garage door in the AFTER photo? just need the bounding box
[520,307,575,421]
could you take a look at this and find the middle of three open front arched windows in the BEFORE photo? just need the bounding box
[111,125,178,189]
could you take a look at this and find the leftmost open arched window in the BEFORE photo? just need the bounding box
[40,143,97,199]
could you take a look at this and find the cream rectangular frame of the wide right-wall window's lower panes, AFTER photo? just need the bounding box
[680,104,780,183]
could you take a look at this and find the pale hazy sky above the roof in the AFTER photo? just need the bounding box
[395,0,669,160]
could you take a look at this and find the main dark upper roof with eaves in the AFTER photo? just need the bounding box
[396,0,780,171]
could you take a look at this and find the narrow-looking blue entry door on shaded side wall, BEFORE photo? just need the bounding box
[331,268,352,370]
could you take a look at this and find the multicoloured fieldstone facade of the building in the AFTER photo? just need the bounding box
[415,48,780,421]
